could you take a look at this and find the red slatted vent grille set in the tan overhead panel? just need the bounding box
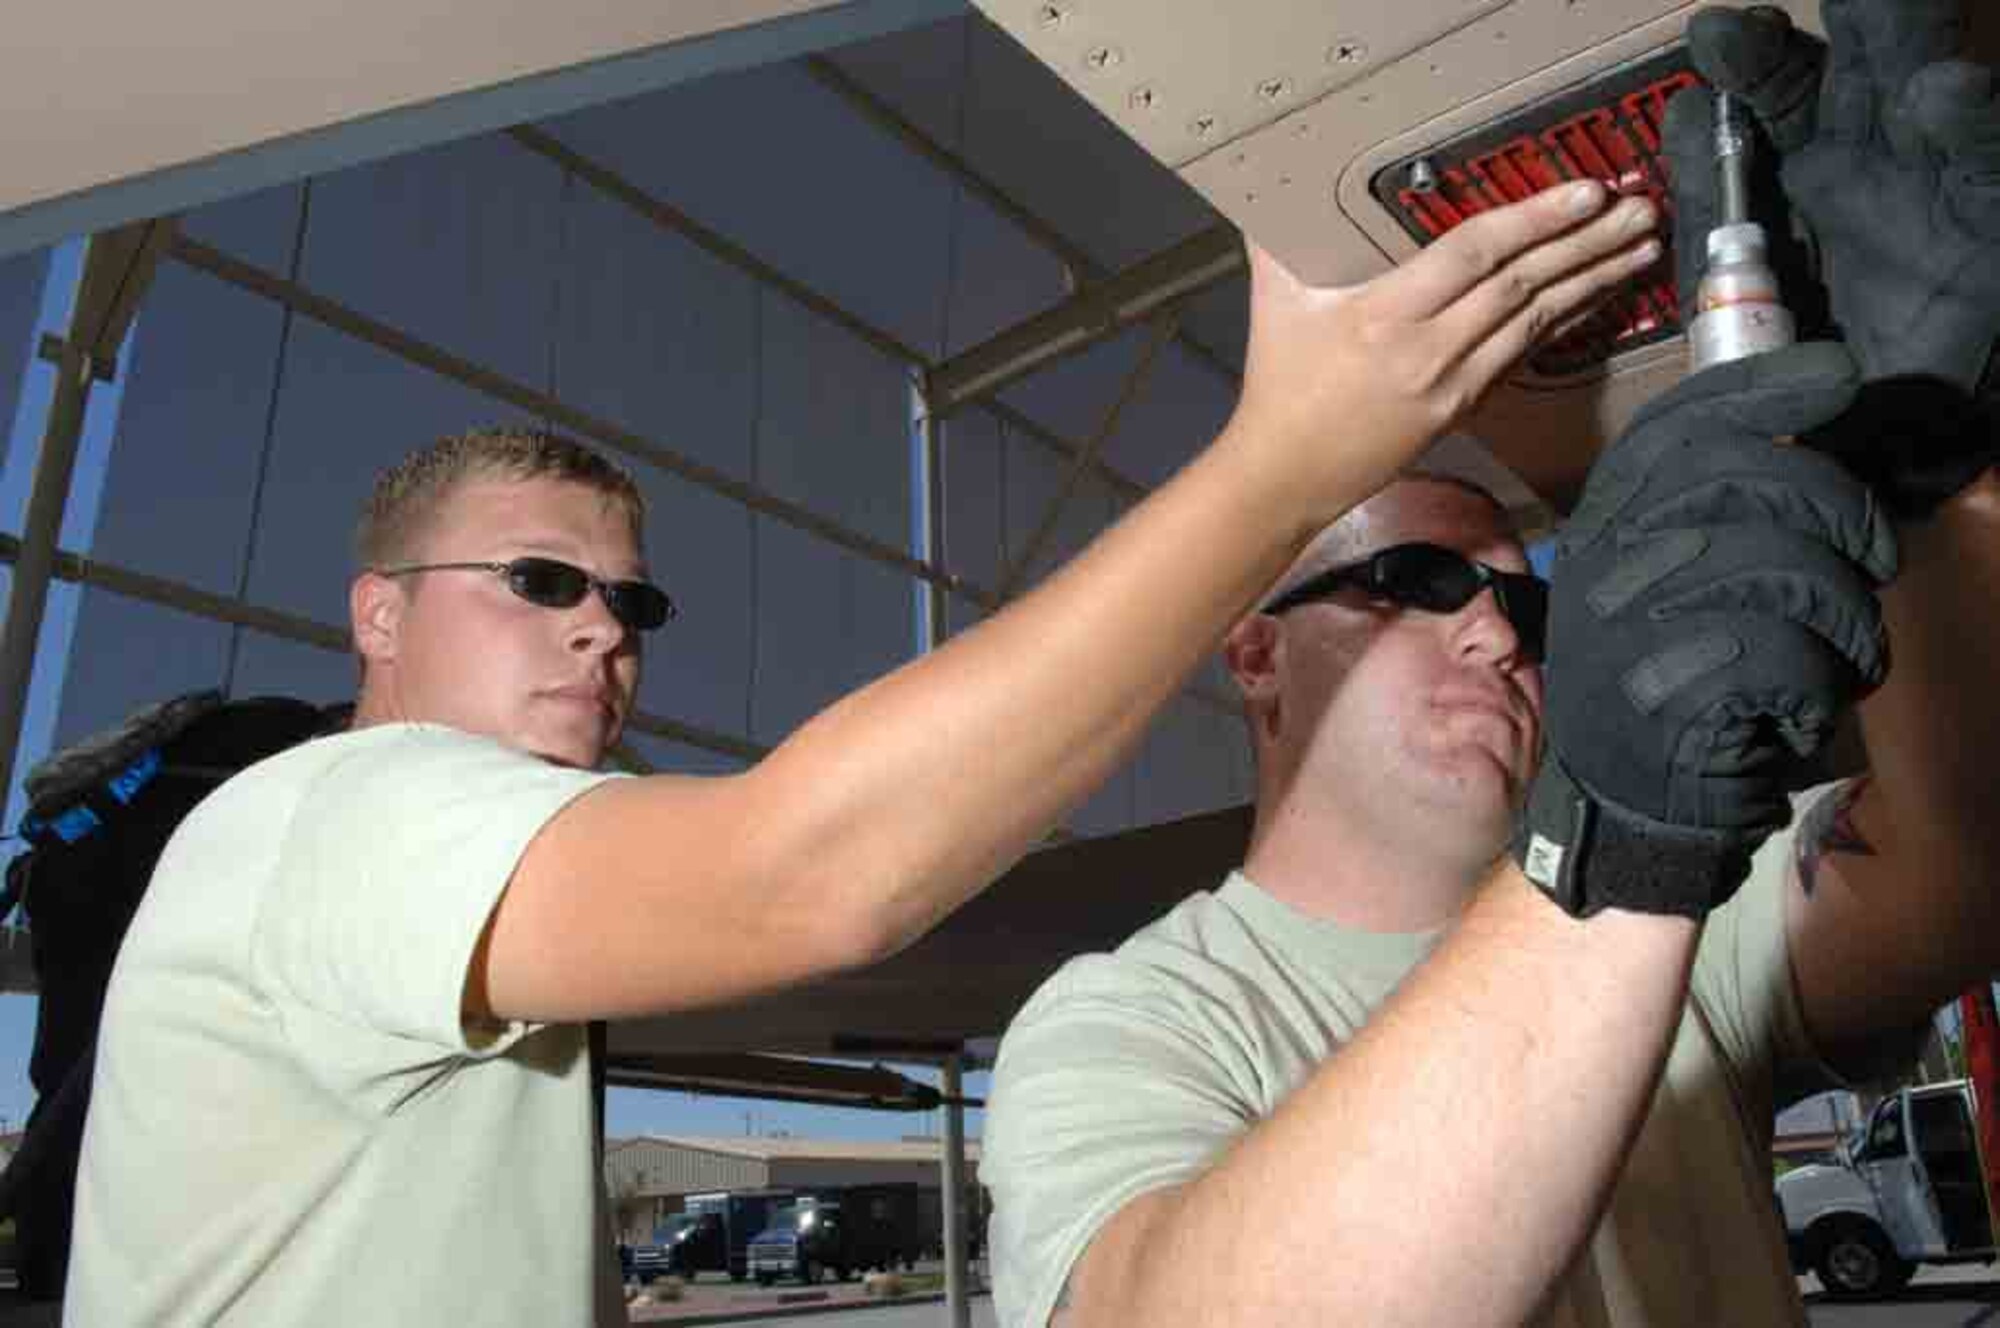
[1374,50,1700,378]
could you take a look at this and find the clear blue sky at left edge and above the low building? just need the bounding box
[0,242,986,1140]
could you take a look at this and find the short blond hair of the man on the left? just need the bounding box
[354,428,646,568]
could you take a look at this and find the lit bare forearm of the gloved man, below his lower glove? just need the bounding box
[1056,866,1698,1328]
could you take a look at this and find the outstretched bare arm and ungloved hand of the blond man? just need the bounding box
[466,190,1652,1020]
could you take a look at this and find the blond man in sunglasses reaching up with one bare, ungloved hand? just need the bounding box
[66,174,1658,1328]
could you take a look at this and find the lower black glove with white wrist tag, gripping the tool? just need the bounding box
[1514,342,1896,918]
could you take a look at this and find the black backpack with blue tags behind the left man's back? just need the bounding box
[0,692,352,1300]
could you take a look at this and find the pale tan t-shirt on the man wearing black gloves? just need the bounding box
[980,816,1824,1328]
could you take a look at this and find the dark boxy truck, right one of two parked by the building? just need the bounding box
[750,1184,924,1286]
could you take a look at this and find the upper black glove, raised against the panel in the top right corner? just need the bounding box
[1664,0,2000,518]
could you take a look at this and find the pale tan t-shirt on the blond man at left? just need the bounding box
[64,724,626,1328]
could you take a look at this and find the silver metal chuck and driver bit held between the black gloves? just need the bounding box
[1688,92,1796,372]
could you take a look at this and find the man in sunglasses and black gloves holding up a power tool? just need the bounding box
[982,0,2000,1328]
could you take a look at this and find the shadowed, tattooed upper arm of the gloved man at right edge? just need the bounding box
[1786,474,2000,1074]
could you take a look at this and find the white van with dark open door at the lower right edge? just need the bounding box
[1778,1080,2000,1300]
